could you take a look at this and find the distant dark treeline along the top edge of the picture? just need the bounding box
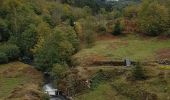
[60,0,141,14]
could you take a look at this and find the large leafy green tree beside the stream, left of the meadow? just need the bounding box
[34,28,74,71]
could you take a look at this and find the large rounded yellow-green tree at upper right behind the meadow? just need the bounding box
[138,0,169,36]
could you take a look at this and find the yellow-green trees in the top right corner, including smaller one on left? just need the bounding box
[124,0,170,36]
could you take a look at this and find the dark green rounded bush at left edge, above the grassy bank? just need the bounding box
[0,44,20,60]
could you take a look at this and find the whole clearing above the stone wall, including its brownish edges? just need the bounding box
[73,35,170,66]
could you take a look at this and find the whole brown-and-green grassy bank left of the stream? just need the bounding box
[0,61,43,100]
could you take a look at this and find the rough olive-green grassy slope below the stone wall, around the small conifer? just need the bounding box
[75,65,170,100]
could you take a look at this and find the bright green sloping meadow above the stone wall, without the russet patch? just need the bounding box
[75,36,170,61]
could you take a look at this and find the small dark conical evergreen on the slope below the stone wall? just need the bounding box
[132,63,146,80]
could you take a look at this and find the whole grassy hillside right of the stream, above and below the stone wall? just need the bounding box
[73,35,170,100]
